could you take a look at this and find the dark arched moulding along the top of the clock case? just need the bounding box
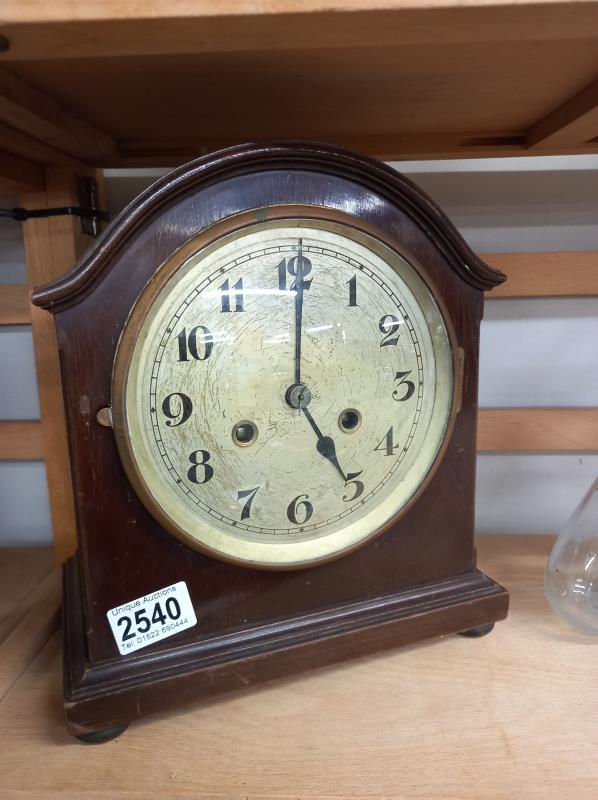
[32,142,505,312]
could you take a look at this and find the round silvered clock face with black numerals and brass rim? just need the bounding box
[113,218,454,569]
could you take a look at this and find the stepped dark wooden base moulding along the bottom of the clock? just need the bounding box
[63,557,508,736]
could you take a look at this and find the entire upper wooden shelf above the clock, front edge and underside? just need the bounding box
[0,0,598,175]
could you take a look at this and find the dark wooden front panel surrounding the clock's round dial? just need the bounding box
[37,148,506,680]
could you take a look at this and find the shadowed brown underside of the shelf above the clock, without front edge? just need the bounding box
[7,42,598,166]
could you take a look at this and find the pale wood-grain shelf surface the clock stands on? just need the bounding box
[0,536,598,800]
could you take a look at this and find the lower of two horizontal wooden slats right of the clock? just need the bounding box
[478,408,598,453]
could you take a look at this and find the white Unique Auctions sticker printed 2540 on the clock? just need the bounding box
[106,581,197,656]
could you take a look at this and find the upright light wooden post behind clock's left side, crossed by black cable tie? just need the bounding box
[21,167,90,563]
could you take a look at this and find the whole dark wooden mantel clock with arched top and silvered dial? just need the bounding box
[33,143,508,740]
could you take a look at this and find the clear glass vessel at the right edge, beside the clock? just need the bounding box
[544,478,598,636]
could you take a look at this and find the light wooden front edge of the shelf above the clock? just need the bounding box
[2,0,598,63]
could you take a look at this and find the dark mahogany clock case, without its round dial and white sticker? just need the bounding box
[33,143,508,737]
